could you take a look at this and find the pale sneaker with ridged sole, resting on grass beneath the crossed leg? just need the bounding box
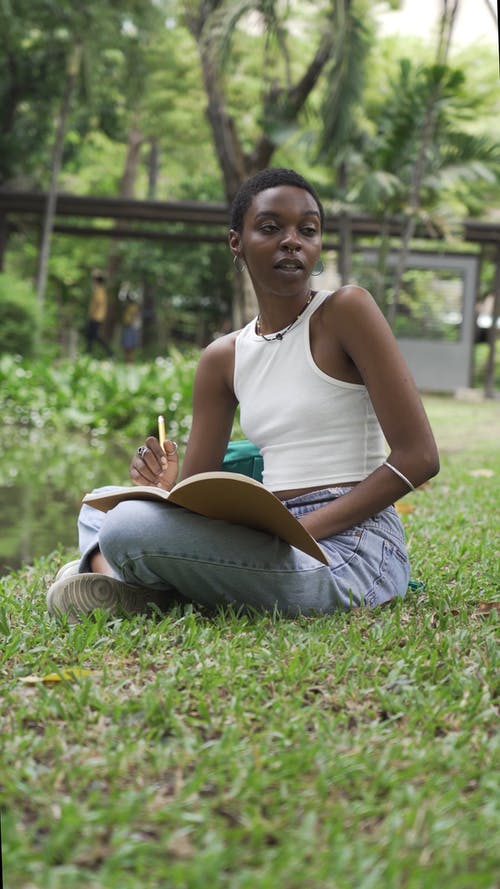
[47,574,165,619]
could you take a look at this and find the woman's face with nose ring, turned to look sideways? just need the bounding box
[230,185,321,292]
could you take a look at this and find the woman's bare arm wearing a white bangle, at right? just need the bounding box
[300,286,439,540]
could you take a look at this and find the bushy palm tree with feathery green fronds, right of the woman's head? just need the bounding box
[352,59,500,308]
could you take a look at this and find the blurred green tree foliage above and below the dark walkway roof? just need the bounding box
[0,0,500,357]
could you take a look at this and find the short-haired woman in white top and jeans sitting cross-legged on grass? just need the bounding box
[48,169,439,616]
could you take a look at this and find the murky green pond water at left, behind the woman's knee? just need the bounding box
[0,432,138,576]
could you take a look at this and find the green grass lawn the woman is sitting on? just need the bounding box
[0,397,500,889]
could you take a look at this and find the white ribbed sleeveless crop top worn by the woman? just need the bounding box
[234,290,386,491]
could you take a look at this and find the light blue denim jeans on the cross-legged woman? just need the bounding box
[78,487,410,617]
